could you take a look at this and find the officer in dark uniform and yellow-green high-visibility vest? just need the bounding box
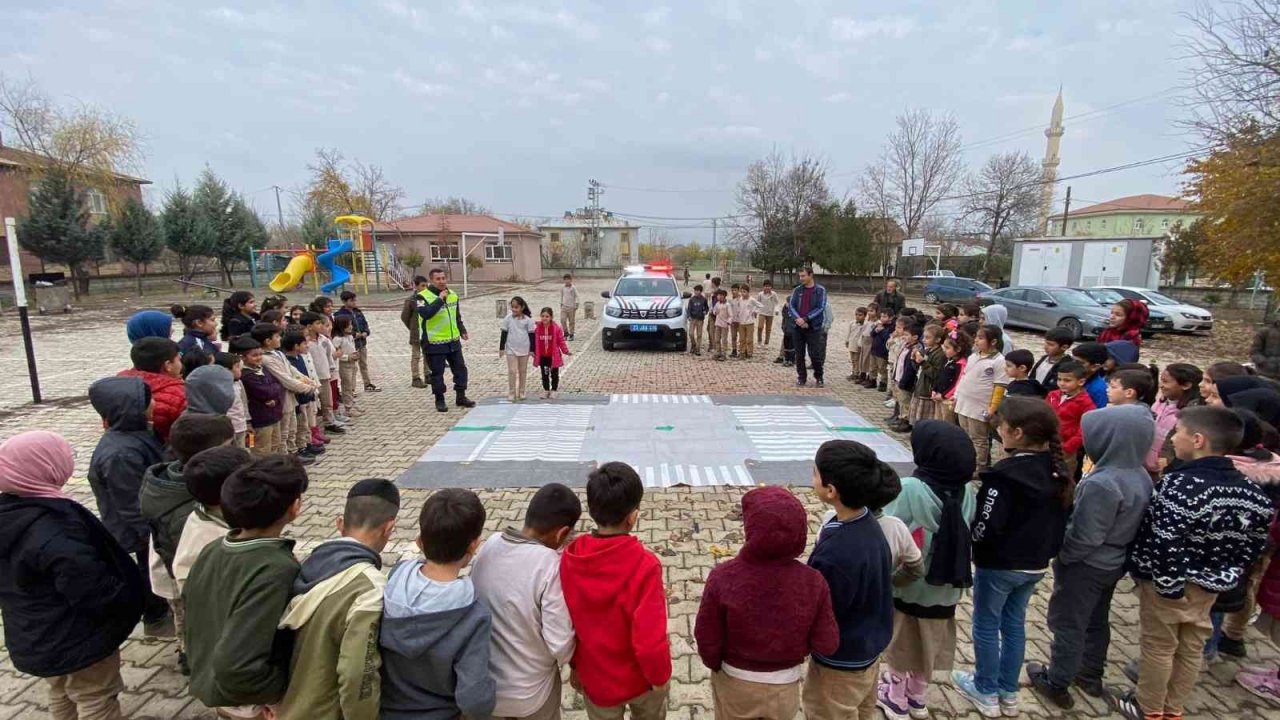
[417,268,476,413]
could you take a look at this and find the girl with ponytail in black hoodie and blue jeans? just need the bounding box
[951,394,1075,717]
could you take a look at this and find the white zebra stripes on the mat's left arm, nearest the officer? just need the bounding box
[472,405,593,462]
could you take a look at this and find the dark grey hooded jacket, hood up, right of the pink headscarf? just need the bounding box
[88,378,164,552]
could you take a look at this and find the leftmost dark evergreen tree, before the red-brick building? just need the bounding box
[18,168,104,297]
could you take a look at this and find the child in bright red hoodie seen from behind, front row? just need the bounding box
[561,462,671,720]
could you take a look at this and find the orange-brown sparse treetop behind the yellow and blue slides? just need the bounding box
[305,147,404,220]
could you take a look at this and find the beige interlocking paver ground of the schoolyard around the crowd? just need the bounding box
[0,281,1264,720]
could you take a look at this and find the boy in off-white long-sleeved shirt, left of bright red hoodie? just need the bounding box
[471,483,582,720]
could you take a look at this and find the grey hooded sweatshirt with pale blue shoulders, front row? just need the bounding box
[379,560,497,720]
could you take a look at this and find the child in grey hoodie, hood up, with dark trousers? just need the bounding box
[1027,405,1156,708]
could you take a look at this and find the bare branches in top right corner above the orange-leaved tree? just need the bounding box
[1184,0,1280,142]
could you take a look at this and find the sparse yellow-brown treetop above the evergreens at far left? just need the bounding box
[0,74,142,188]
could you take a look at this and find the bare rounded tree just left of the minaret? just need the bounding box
[964,152,1043,279]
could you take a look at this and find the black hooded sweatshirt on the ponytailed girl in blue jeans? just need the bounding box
[973,451,1070,571]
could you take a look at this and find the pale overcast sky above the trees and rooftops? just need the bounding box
[0,0,1193,241]
